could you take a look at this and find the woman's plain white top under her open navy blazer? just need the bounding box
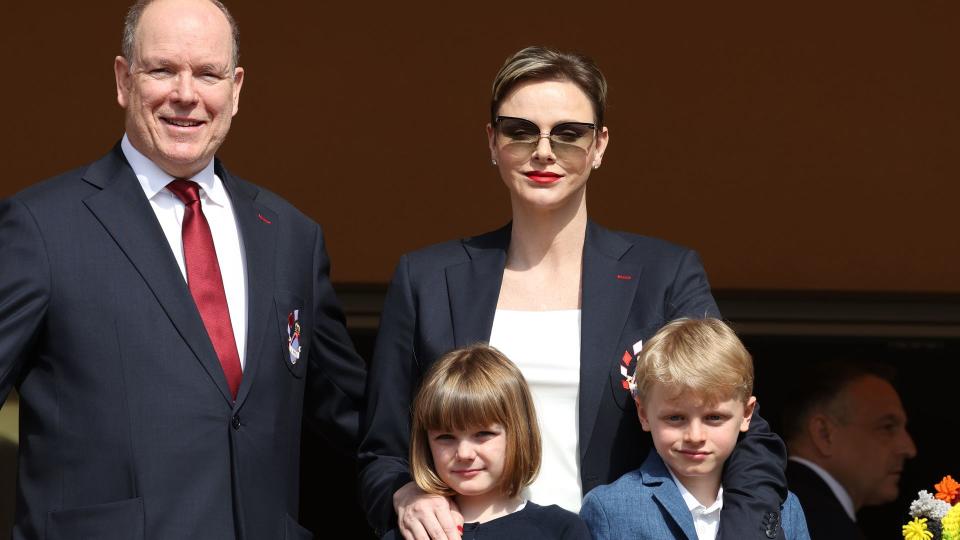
[490,309,583,512]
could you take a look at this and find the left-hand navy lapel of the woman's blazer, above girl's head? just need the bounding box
[446,225,510,347]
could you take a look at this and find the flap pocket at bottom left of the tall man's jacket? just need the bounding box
[46,497,145,540]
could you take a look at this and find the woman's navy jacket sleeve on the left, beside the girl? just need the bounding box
[359,256,419,532]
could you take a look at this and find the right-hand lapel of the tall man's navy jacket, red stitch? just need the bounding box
[217,161,280,408]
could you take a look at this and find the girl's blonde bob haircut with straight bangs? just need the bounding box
[410,344,541,497]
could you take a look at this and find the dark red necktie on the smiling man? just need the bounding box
[167,178,243,399]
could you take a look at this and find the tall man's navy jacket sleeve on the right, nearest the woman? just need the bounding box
[304,226,366,456]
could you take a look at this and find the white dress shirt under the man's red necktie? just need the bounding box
[120,135,247,368]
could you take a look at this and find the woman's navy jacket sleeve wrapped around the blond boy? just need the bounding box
[665,247,787,540]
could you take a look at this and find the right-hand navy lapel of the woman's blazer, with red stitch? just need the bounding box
[580,221,642,460]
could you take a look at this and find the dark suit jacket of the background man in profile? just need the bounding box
[787,461,865,540]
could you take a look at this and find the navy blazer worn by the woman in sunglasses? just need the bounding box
[360,222,786,538]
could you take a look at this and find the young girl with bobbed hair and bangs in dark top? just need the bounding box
[383,345,590,540]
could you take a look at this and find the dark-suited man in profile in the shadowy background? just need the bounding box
[783,359,917,540]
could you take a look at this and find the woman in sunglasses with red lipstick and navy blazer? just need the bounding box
[360,47,786,540]
